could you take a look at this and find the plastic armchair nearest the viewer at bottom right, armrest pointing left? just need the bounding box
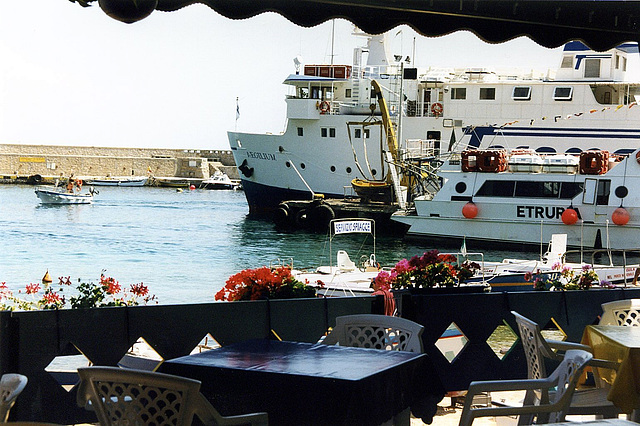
[460,350,593,426]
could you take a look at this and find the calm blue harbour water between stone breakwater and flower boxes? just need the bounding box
[0,185,537,304]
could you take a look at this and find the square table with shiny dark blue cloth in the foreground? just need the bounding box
[159,340,444,425]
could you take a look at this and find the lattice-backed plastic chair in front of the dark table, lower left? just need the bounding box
[77,367,268,426]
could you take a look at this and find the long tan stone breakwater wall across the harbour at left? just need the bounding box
[0,144,238,182]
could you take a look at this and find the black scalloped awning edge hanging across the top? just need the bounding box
[76,0,640,50]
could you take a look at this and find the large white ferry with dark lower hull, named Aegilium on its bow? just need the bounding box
[228,30,640,214]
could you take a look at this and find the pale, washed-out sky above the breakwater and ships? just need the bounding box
[0,0,559,149]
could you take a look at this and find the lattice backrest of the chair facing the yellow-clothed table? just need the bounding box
[511,311,556,379]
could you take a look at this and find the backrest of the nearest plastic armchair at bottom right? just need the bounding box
[549,349,593,423]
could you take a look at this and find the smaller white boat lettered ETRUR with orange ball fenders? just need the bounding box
[391,149,640,249]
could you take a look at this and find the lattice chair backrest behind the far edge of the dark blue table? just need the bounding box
[323,314,424,353]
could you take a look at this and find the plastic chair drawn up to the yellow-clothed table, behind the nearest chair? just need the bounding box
[511,311,620,424]
